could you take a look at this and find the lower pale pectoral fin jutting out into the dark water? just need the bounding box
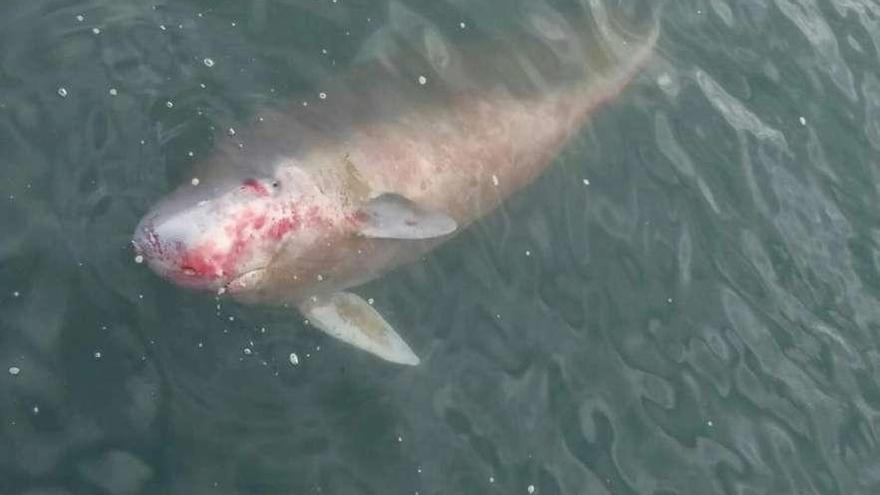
[298,292,419,366]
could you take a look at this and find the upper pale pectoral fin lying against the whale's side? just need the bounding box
[360,193,458,240]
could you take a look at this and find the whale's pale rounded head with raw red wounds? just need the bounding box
[132,173,302,291]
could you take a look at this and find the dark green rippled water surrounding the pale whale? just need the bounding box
[0,0,880,495]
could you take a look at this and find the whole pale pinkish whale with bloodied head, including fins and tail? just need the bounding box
[132,2,658,365]
